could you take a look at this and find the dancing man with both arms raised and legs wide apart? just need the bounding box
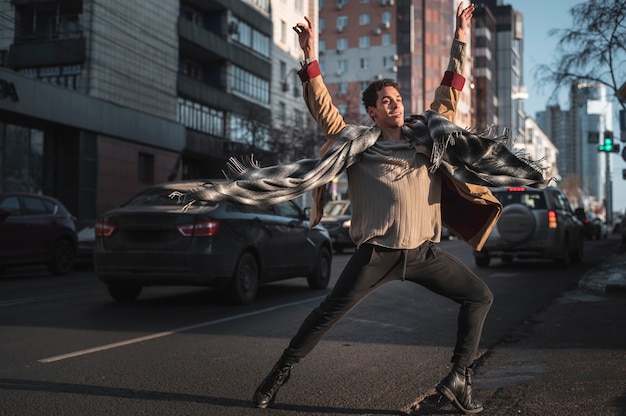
[253,4,494,413]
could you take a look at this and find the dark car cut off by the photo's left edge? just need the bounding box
[0,192,77,275]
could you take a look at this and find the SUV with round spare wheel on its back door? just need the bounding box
[474,187,584,267]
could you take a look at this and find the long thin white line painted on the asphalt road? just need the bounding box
[37,296,325,363]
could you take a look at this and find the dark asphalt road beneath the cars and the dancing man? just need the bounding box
[0,239,617,416]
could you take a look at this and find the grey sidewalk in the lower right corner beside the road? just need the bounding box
[474,239,626,416]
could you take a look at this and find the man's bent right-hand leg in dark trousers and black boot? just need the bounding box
[407,245,493,413]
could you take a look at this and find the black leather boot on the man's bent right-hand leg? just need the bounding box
[436,367,483,413]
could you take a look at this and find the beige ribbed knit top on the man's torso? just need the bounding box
[347,138,441,249]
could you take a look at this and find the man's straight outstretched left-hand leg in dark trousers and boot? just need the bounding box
[253,245,402,408]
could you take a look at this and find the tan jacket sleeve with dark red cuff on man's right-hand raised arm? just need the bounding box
[430,39,465,121]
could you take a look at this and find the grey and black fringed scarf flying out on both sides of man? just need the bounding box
[170,110,549,210]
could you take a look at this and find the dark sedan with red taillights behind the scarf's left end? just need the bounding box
[94,181,332,303]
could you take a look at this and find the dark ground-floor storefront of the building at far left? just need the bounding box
[0,68,185,227]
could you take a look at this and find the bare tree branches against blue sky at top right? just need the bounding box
[536,0,626,110]
